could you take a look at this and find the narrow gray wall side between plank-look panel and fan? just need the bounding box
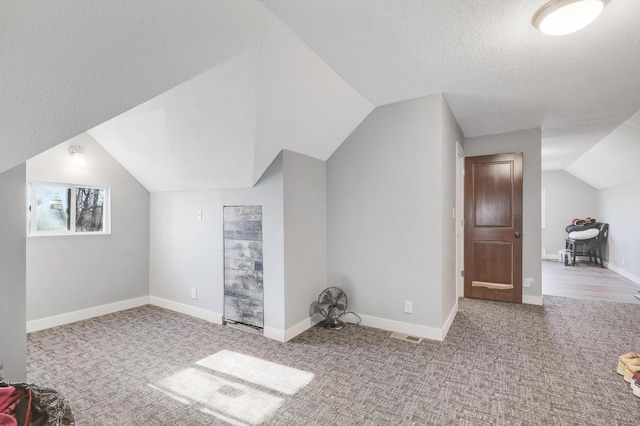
[284,151,328,329]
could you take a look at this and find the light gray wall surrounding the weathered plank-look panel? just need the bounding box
[149,153,285,330]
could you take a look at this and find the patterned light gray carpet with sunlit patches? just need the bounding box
[28,297,640,426]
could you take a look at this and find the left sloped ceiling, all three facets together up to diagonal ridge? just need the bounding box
[0,0,374,192]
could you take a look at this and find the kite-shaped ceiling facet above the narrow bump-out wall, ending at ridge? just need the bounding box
[253,20,374,181]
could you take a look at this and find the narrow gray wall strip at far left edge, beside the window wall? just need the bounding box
[0,163,27,382]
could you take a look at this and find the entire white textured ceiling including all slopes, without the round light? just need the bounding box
[0,0,640,191]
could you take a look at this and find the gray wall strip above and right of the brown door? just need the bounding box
[463,129,542,301]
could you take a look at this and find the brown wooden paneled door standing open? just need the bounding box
[464,152,522,303]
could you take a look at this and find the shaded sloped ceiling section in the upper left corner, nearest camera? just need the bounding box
[0,0,273,175]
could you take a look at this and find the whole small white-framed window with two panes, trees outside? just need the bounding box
[27,182,110,236]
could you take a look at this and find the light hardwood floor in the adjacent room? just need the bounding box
[542,260,640,304]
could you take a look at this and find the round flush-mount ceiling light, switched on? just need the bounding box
[531,0,609,35]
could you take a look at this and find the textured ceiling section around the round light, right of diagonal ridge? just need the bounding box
[263,0,640,174]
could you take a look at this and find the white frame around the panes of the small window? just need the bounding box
[27,181,111,237]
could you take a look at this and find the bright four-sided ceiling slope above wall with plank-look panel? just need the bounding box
[88,49,260,192]
